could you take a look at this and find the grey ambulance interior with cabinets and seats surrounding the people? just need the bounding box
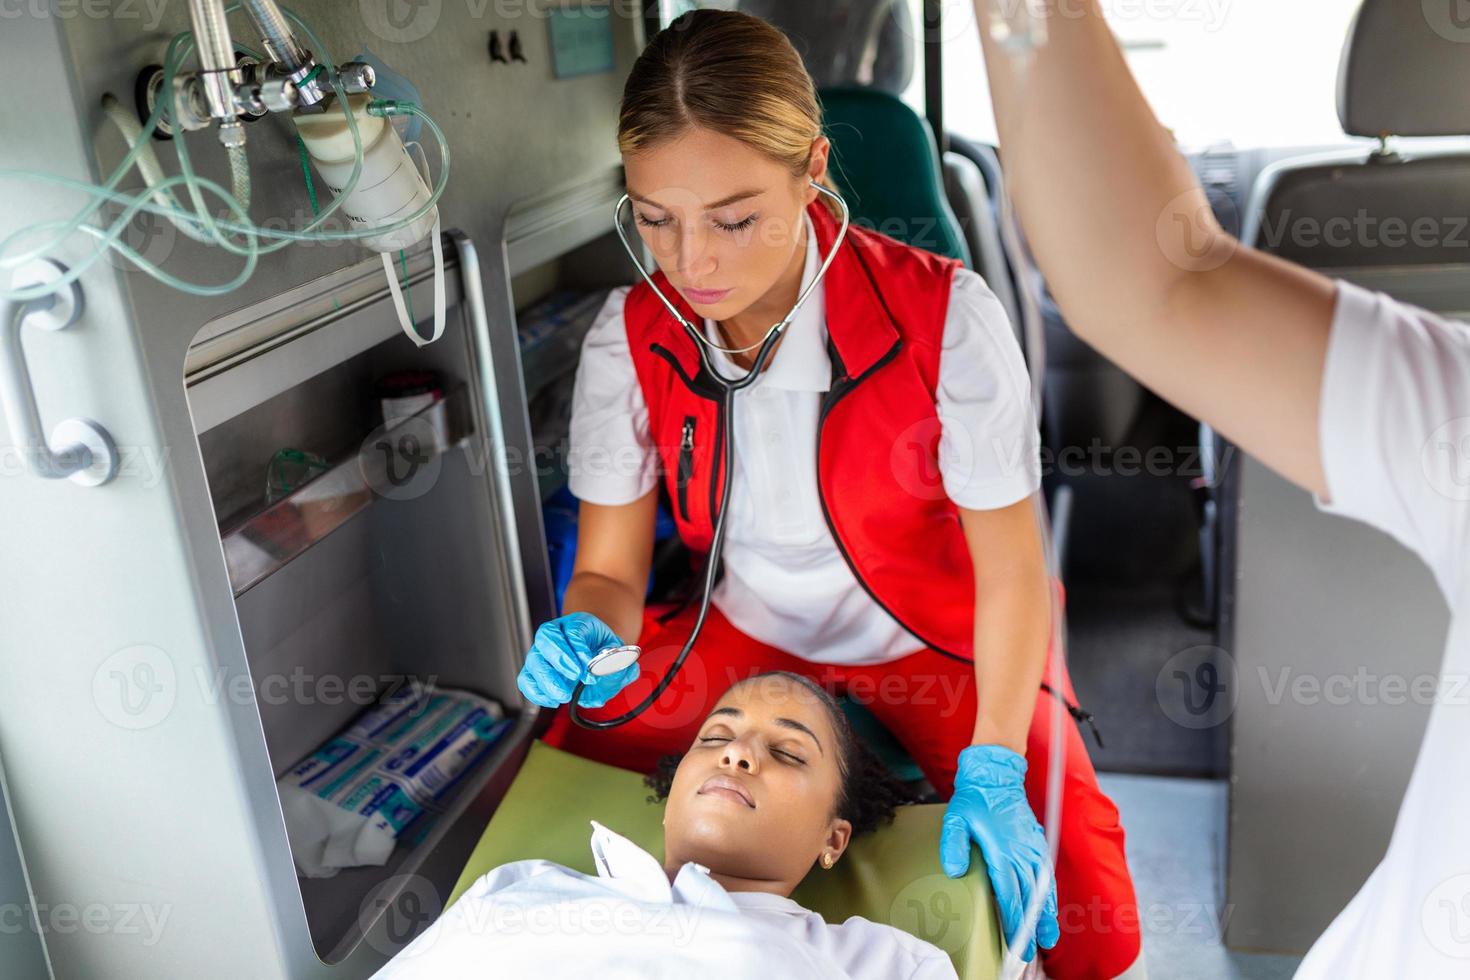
[0,0,1452,980]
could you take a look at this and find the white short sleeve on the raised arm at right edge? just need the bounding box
[1317,282,1470,595]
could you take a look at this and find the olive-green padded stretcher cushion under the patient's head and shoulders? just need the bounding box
[450,742,1001,980]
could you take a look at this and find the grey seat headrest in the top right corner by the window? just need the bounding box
[1338,0,1470,137]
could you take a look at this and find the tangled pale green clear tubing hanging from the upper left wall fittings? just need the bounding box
[0,4,450,301]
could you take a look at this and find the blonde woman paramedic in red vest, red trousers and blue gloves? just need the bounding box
[519,10,1142,980]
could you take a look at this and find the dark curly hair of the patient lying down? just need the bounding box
[644,670,916,836]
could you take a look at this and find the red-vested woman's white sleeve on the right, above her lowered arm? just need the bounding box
[935,269,1041,510]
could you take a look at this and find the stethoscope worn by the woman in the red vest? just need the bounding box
[569,181,851,729]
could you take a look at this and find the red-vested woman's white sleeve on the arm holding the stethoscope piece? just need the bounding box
[567,287,659,507]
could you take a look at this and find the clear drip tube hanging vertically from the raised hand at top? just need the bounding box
[975,0,1069,980]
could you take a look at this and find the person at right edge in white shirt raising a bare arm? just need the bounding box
[976,0,1470,980]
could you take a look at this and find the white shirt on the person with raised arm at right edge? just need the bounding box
[1297,284,1470,980]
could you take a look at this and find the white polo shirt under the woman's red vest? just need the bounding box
[569,217,1041,664]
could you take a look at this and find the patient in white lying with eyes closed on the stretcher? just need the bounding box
[378,673,956,980]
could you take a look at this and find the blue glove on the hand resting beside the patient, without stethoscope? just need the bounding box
[939,745,1061,962]
